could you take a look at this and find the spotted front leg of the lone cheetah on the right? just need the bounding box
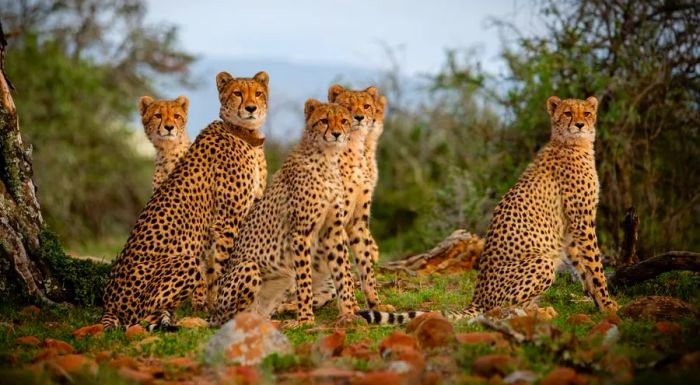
[564,199,618,311]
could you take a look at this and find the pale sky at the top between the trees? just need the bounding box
[147,0,536,75]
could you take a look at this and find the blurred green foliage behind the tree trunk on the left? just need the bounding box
[0,0,192,249]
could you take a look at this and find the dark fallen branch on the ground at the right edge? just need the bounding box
[608,251,700,287]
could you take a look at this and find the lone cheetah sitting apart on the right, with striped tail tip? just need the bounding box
[359,96,617,323]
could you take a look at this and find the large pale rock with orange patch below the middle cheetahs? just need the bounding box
[204,312,292,365]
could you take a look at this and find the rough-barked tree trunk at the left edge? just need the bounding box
[0,22,60,301]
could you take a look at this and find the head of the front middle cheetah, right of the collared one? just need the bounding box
[304,99,350,147]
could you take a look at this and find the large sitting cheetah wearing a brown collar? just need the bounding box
[101,72,268,328]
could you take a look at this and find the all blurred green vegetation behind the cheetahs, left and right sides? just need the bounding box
[0,0,700,257]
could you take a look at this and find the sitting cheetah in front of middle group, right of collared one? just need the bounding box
[211,99,358,325]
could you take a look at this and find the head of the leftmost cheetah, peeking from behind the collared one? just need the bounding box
[139,96,190,147]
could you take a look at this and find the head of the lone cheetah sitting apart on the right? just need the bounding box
[547,96,598,142]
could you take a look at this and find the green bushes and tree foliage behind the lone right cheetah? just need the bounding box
[372,0,700,257]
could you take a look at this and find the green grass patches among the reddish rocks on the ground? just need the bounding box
[0,273,700,384]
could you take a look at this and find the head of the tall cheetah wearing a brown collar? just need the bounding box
[216,71,270,130]
